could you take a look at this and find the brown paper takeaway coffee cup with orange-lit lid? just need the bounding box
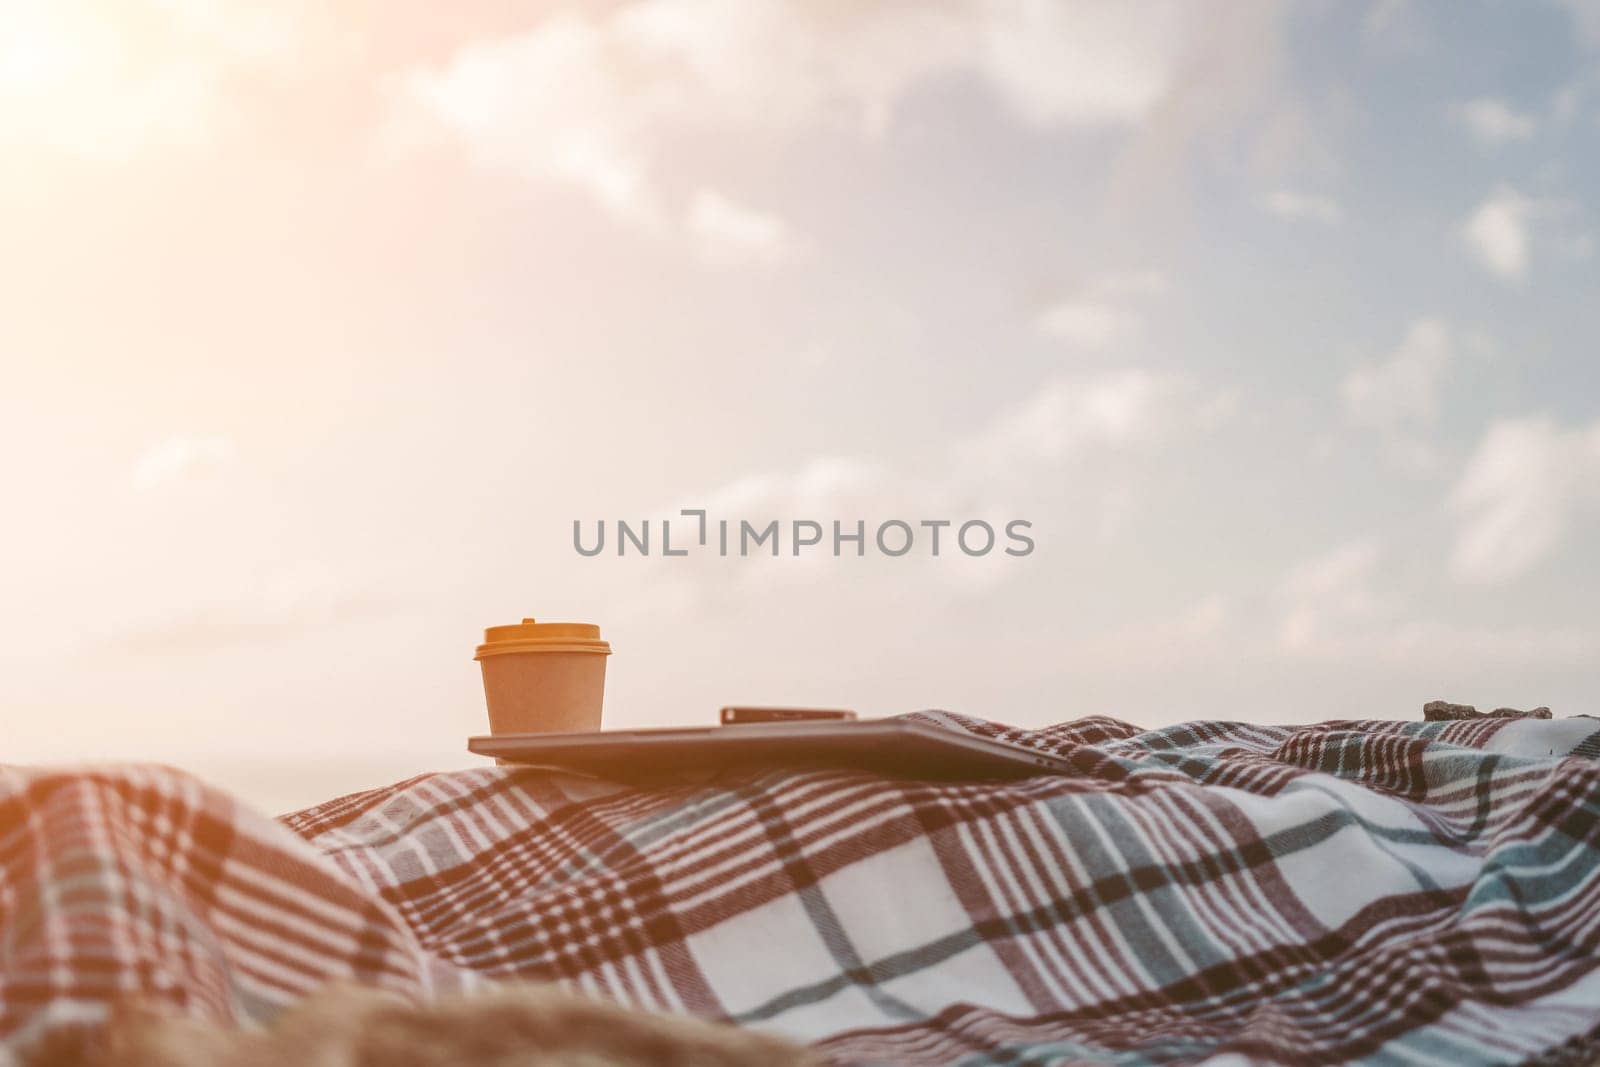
[474,619,611,734]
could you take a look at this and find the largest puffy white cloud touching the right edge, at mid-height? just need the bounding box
[1450,418,1600,584]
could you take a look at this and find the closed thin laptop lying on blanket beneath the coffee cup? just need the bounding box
[467,718,1072,781]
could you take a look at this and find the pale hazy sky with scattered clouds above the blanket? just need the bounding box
[0,0,1600,808]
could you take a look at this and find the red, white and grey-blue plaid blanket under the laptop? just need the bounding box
[0,715,1600,1065]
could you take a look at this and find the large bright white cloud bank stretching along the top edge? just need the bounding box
[398,0,1197,222]
